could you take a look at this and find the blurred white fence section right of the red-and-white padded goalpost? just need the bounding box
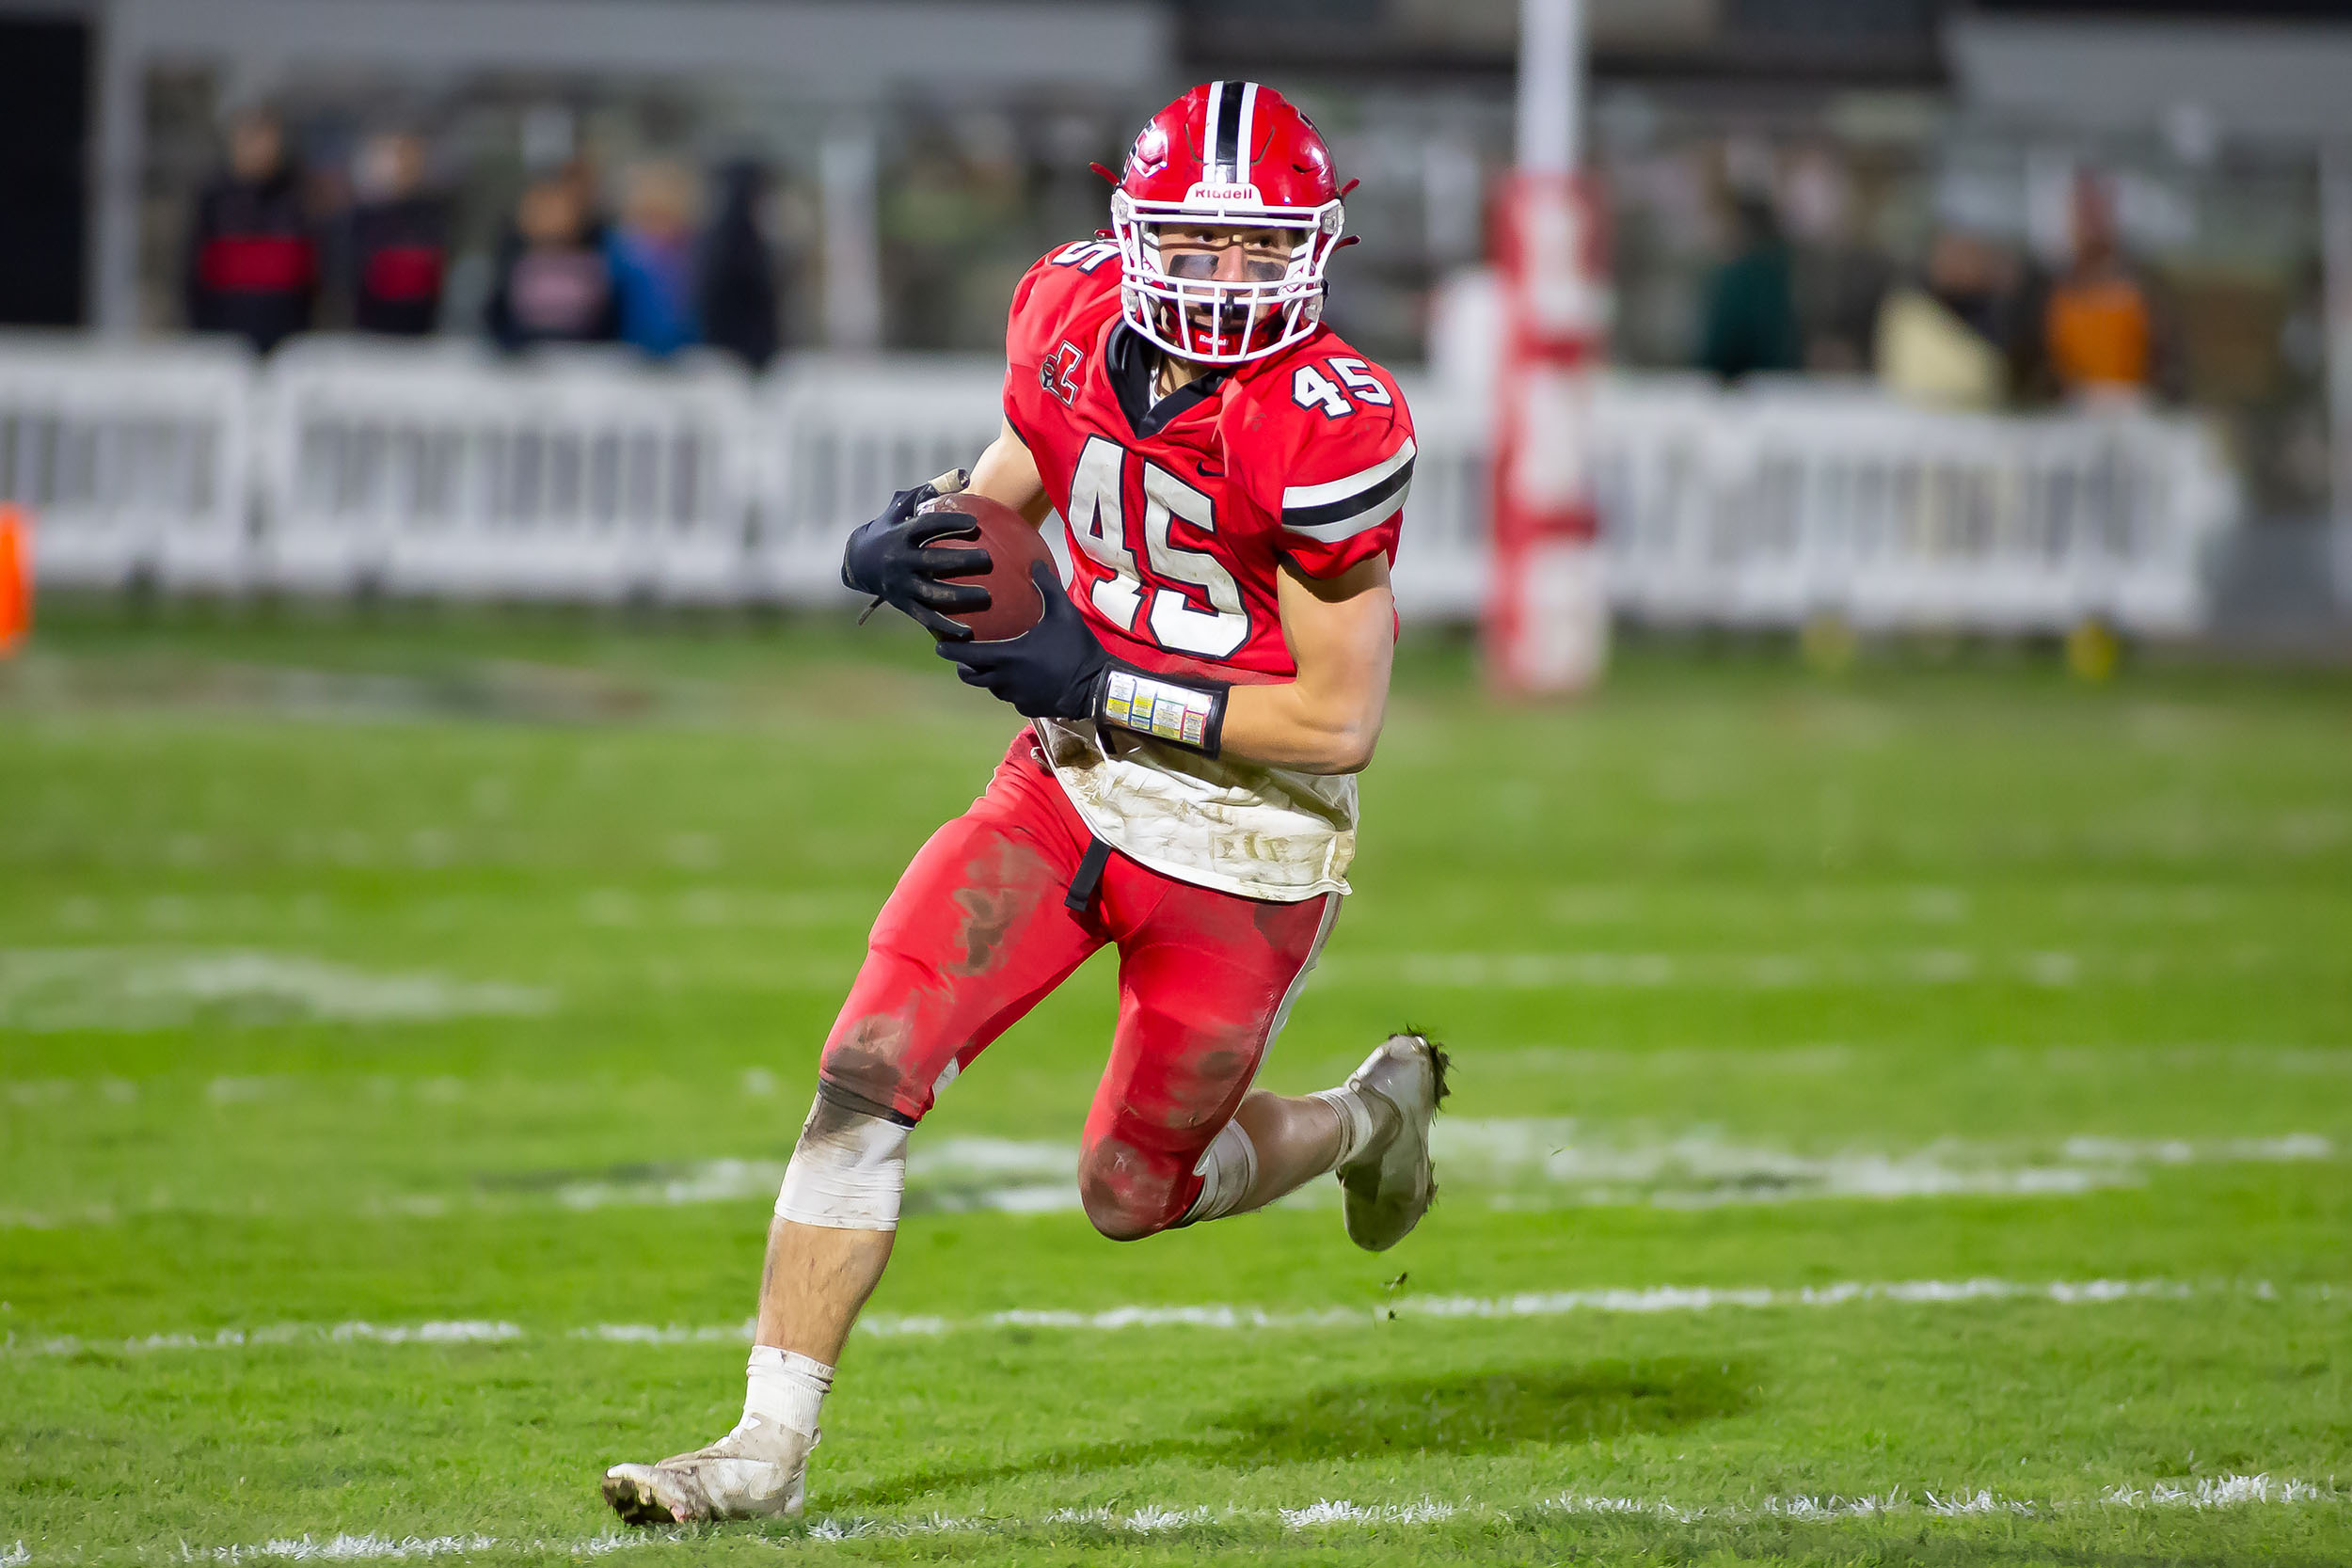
[1595,381,2239,632]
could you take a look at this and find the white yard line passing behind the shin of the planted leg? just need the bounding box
[13,1279,2347,1363]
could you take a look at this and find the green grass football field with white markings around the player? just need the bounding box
[0,607,2352,1568]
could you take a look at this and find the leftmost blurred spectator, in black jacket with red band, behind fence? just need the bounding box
[186,108,318,353]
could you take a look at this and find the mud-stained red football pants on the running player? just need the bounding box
[818,729,1339,1242]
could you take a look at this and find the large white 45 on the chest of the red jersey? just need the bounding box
[1071,435,1249,658]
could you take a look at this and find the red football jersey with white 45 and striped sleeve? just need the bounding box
[1005,240,1414,682]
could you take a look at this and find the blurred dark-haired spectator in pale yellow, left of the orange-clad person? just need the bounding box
[1877,230,2026,409]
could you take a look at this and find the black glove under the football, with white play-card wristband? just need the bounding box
[939,562,1232,757]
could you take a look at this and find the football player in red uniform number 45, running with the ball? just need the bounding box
[605,82,1447,1524]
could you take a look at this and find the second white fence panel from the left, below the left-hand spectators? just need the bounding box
[254,341,757,599]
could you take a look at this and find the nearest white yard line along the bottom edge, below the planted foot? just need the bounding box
[27,1472,2345,1568]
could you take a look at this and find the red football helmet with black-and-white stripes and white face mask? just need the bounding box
[1110,82,1343,364]
